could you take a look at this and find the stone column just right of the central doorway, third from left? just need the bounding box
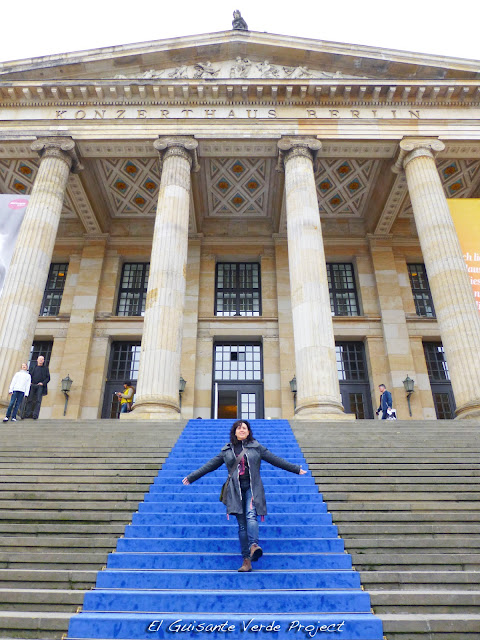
[278,138,347,420]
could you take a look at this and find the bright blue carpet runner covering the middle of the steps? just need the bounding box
[68,420,383,640]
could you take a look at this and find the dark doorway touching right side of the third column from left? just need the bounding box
[335,342,373,420]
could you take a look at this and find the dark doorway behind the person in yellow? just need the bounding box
[102,342,141,418]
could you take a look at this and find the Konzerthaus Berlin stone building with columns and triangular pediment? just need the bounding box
[0,20,480,420]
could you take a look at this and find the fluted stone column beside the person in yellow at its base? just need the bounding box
[128,136,198,420]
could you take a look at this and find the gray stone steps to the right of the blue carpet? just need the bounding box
[292,420,480,640]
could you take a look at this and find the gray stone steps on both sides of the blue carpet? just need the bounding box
[0,420,480,640]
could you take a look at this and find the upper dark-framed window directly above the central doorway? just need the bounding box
[215,262,261,316]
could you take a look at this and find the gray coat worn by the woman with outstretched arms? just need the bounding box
[187,440,300,516]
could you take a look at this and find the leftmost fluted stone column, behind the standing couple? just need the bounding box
[0,137,80,404]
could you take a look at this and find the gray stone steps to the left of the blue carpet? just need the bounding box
[0,420,185,639]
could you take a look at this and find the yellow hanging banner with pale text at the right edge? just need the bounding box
[448,198,480,311]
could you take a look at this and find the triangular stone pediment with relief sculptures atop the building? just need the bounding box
[0,31,480,81]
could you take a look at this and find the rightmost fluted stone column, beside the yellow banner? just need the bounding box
[394,138,480,418]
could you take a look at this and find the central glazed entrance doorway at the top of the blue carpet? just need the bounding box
[212,343,264,420]
